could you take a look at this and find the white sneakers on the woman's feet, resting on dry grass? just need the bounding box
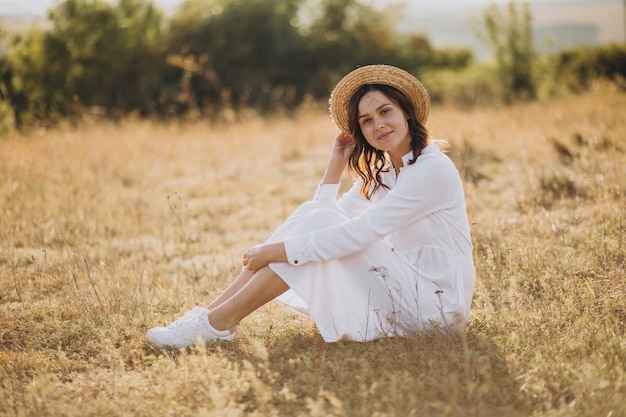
[146,307,235,349]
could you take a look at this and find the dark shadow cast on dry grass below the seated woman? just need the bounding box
[218,329,527,416]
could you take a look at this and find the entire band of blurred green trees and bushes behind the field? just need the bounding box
[0,0,626,133]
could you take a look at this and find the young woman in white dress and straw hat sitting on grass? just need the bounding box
[147,65,475,348]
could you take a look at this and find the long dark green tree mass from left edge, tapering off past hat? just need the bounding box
[0,0,471,124]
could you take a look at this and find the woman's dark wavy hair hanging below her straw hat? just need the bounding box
[348,84,429,200]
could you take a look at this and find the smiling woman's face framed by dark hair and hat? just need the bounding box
[359,90,411,157]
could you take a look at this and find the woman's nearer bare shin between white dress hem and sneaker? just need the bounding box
[209,266,289,330]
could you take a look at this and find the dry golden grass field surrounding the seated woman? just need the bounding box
[0,87,626,417]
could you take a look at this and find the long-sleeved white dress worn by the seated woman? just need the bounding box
[268,143,475,342]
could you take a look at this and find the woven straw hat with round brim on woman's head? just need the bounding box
[329,65,430,135]
